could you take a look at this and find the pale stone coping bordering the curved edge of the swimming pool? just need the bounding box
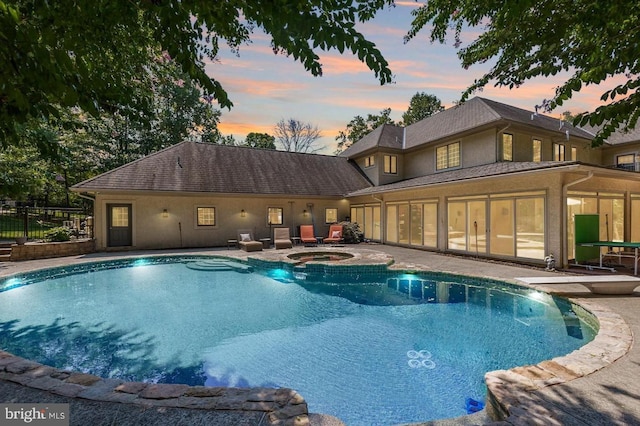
[0,248,633,425]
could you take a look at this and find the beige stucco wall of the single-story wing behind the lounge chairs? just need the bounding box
[94,193,349,250]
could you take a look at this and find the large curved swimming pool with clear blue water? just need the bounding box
[0,257,595,425]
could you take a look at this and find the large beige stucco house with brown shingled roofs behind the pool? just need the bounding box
[72,98,640,265]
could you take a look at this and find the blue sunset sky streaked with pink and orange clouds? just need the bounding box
[207,1,616,154]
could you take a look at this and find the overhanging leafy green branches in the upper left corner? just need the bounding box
[0,0,393,151]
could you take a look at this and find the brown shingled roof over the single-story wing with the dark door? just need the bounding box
[72,142,371,197]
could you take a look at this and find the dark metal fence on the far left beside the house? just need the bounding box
[0,205,93,240]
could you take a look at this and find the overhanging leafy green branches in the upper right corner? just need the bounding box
[405,0,640,146]
